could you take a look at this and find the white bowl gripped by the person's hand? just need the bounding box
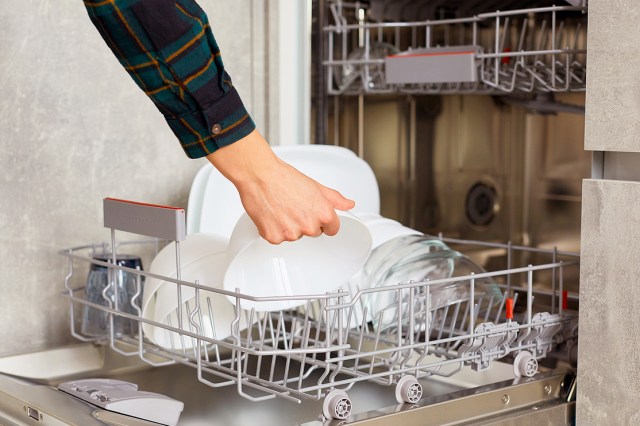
[224,211,371,311]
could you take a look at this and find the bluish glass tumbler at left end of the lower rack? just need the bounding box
[81,254,144,337]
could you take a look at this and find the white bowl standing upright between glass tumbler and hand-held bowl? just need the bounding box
[142,234,246,350]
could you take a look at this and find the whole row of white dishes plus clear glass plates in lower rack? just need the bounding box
[143,145,496,349]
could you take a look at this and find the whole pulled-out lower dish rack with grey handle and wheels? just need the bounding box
[61,200,579,419]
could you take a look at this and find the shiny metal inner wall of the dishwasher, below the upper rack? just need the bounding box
[327,93,591,290]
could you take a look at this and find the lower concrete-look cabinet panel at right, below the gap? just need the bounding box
[577,180,640,425]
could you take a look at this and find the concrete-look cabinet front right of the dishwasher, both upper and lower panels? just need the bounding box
[576,0,640,425]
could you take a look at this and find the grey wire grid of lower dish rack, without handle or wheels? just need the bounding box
[62,240,577,401]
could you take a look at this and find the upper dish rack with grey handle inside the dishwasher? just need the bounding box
[323,0,587,95]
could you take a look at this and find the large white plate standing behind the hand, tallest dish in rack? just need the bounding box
[198,145,380,240]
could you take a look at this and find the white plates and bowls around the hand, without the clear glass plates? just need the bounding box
[143,145,388,348]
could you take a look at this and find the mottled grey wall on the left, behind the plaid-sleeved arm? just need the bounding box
[0,0,275,355]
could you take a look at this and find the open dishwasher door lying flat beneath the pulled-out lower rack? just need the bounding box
[0,345,575,426]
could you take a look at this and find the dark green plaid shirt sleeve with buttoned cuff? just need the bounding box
[84,0,255,158]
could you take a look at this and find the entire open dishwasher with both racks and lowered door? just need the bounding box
[0,0,586,425]
